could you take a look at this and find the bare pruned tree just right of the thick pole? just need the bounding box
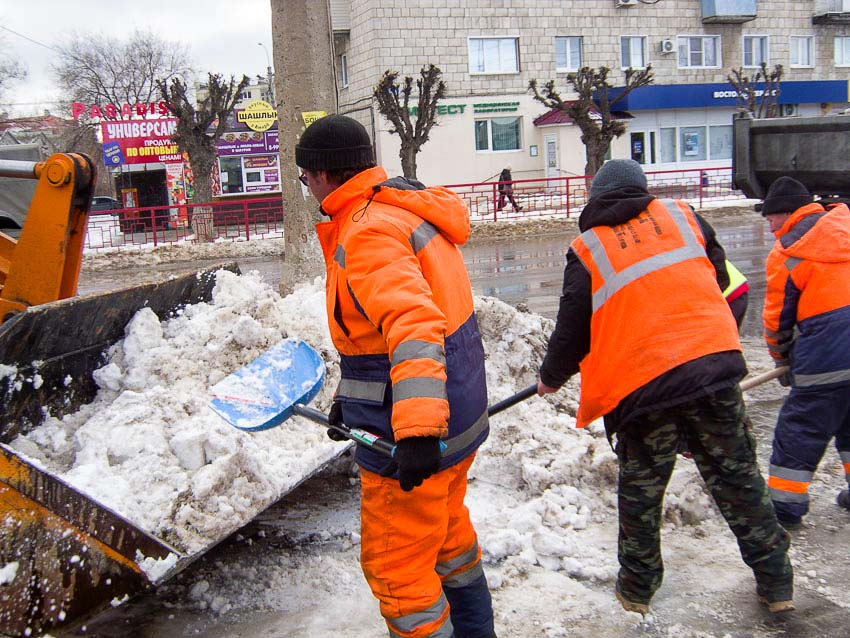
[372,64,446,178]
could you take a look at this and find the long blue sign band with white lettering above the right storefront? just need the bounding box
[611,80,850,111]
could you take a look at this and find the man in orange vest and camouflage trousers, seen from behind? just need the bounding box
[538,160,793,614]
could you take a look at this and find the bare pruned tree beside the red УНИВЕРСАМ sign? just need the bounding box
[156,73,248,241]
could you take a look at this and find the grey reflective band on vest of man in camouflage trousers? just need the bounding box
[582,199,705,312]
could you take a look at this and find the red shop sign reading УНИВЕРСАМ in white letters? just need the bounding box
[100,117,182,166]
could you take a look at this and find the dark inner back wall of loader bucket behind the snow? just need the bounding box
[0,263,239,443]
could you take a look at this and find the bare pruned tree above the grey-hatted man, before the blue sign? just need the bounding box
[528,64,654,176]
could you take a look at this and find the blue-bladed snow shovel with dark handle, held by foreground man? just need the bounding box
[210,339,537,457]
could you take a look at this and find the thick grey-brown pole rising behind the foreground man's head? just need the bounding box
[271,0,337,294]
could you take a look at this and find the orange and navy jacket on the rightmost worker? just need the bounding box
[762,202,850,387]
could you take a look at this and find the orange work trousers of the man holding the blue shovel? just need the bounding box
[360,454,496,638]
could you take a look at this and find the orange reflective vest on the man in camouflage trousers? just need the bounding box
[572,199,741,427]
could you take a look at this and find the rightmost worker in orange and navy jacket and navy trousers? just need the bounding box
[761,177,850,527]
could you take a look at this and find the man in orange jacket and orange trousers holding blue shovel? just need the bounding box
[295,115,495,638]
